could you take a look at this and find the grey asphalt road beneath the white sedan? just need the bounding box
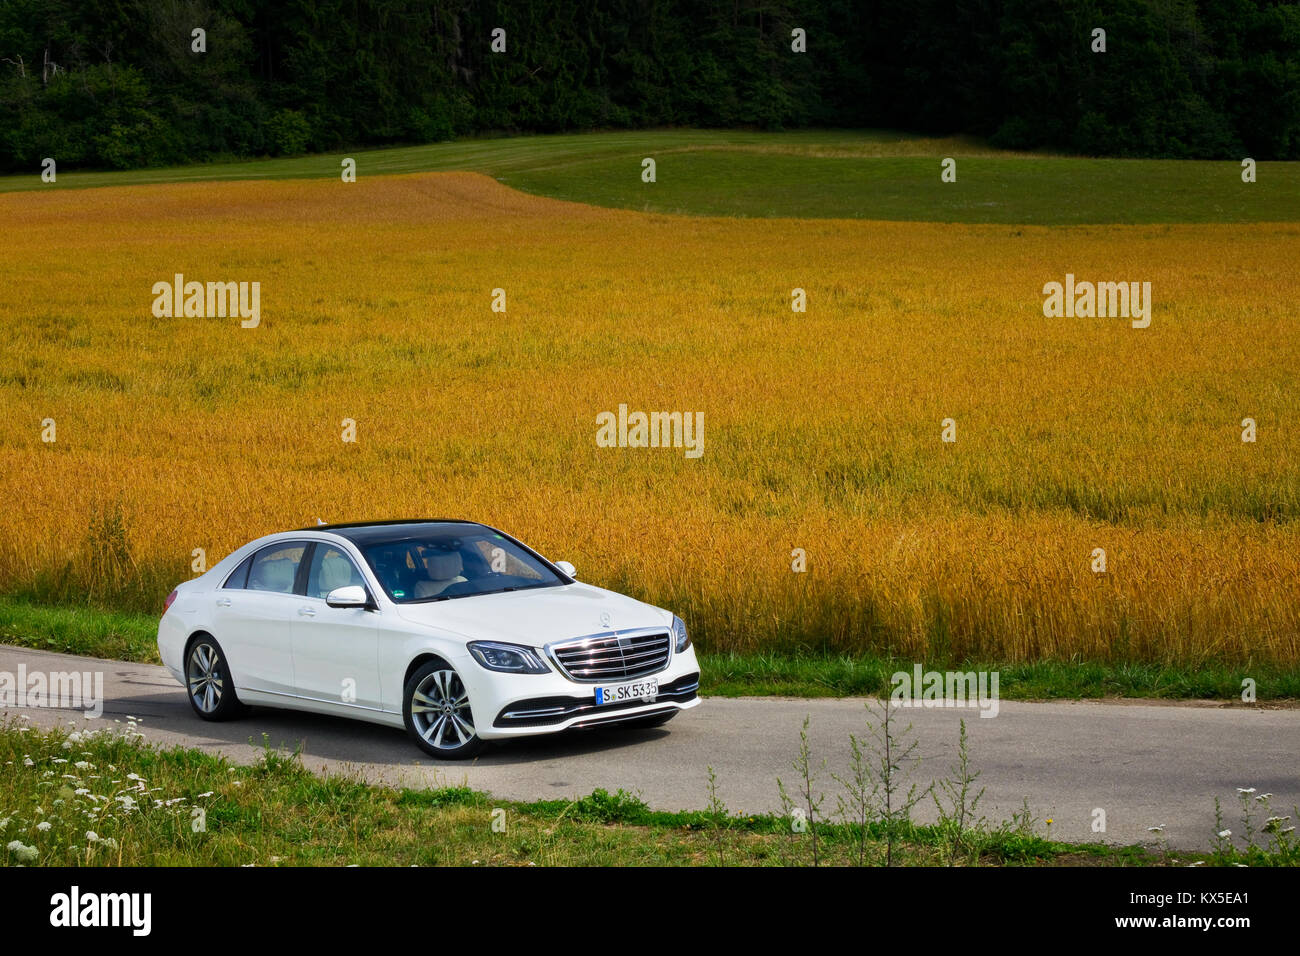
[0,645,1300,848]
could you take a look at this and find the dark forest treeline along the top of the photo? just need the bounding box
[0,0,1300,170]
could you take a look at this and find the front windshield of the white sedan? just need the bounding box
[361,527,564,604]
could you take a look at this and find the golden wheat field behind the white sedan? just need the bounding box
[0,173,1300,665]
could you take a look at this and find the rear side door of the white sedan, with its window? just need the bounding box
[213,541,308,695]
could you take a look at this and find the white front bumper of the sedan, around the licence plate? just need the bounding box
[456,648,699,740]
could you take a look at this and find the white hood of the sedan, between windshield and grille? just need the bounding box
[398,584,672,648]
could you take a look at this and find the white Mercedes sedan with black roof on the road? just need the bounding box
[159,520,699,758]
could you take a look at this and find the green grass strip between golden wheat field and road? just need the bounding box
[0,596,1300,701]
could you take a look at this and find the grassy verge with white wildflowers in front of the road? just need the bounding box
[0,723,1253,866]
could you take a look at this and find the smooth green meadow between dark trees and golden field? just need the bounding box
[0,130,1300,225]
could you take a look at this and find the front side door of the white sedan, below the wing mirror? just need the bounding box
[293,541,380,710]
